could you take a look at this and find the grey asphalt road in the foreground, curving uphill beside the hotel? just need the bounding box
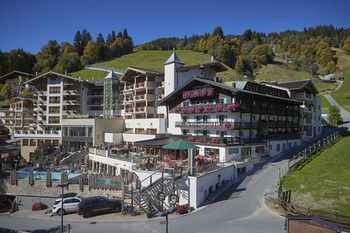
[0,160,287,233]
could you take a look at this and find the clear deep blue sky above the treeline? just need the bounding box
[0,0,350,53]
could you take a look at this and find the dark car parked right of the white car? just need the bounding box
[78,197,122,218]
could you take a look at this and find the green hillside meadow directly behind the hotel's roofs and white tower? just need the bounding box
[72,50,242,81]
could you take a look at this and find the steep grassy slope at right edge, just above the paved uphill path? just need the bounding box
[332,49,350,111]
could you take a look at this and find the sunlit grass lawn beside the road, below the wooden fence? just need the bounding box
[283,136,350,216]
